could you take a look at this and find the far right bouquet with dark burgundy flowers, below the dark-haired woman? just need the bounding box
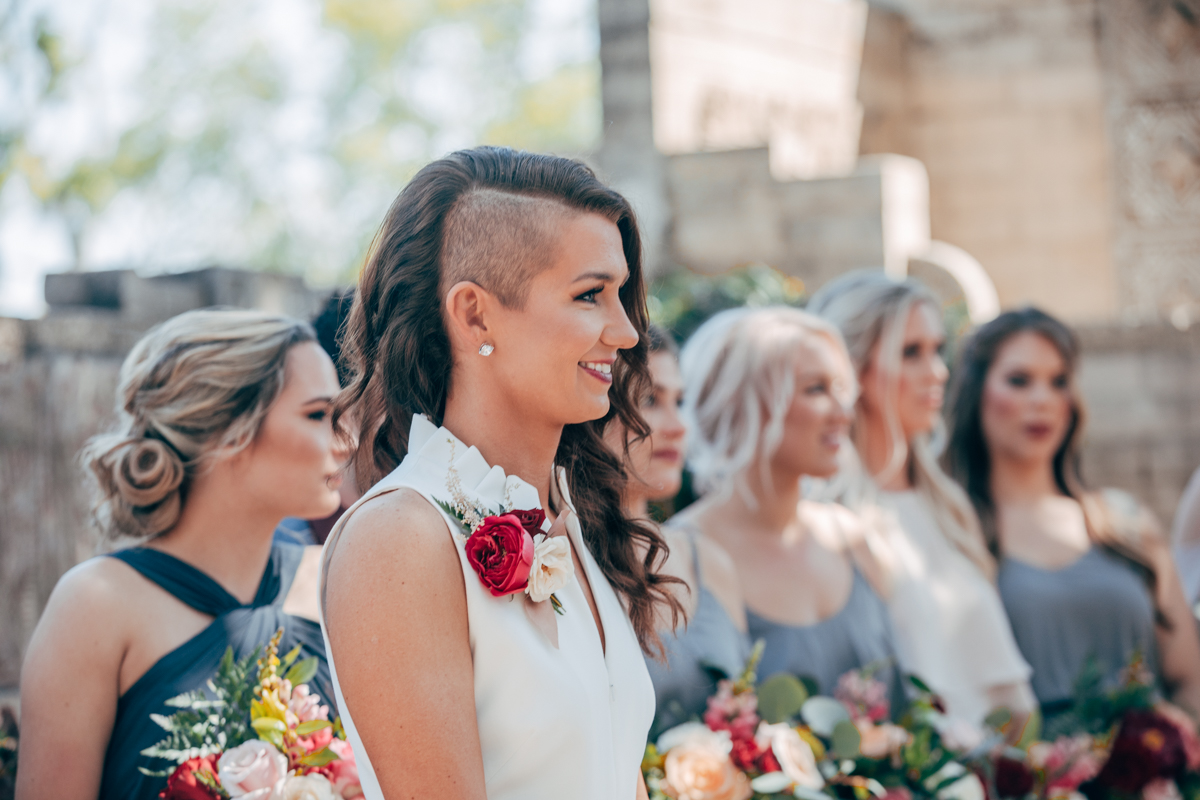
[991,656,1200,800]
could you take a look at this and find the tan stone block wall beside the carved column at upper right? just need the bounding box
[859,0,1118,323]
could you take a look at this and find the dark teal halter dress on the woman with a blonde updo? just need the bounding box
[100,543,336,800]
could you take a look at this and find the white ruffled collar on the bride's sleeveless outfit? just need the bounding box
[408,414,575,529]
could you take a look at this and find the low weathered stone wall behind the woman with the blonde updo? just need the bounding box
[0,269,323,688]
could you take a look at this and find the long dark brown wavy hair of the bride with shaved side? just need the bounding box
[334,146,683,656]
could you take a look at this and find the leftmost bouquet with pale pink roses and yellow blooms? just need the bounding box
[139,630,362,800]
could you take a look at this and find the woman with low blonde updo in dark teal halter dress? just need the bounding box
[17,311,348,800]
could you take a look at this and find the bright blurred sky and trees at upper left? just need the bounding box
[0,0,600,315]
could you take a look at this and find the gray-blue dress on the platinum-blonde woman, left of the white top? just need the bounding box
[746,569,902,710]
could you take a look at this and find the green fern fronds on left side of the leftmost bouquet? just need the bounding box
[138,648,263,776]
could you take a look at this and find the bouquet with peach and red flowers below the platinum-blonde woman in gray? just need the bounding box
[642,643,984,800]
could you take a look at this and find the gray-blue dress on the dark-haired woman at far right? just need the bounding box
[997,547,1158,708]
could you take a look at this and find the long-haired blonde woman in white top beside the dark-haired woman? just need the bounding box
[808,271,1034,735]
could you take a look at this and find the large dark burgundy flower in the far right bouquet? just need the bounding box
[1097,711,1187,794]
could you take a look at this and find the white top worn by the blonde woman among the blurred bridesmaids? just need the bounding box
[878,491,1031,724]
